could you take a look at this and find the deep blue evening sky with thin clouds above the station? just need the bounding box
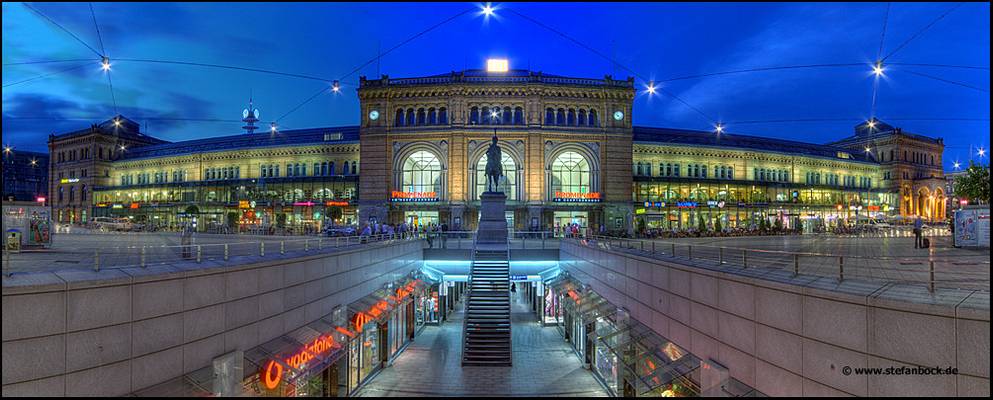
[2,2,990,169]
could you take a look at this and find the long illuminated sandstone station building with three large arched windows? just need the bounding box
[49,66,945,232]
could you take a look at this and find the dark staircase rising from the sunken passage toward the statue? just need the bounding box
[462,248,512,367]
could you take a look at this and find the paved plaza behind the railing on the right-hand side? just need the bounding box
[624,234,990,291]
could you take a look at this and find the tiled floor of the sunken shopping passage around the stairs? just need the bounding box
[359,295,607,397]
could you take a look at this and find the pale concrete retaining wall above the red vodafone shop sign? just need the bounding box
[3,241,423,396]
